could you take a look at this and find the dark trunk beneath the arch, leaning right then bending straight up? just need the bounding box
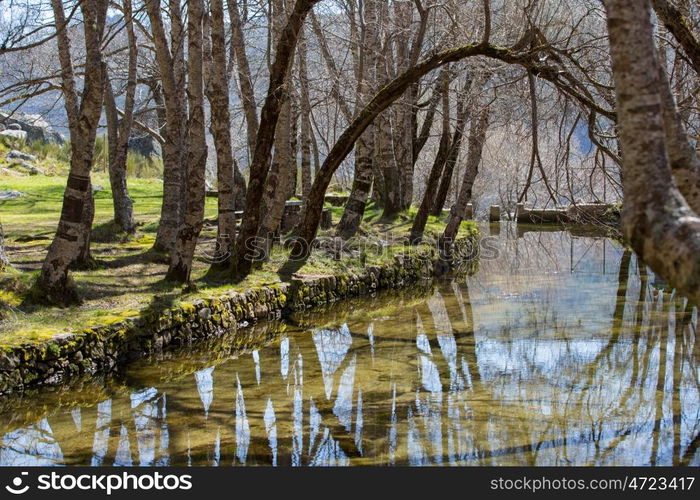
[410,66,452,245]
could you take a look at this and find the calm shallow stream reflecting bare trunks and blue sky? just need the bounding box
[0,225,700,465]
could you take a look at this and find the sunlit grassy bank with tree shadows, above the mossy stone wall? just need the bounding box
[0,137,477,346]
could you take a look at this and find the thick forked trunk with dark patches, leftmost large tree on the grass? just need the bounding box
[36,0,108,305]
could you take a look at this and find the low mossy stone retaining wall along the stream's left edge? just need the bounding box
[0,234,482,393]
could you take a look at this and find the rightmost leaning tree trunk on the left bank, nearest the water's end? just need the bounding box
[440,107,489,252]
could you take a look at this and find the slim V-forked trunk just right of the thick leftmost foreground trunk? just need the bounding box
[104,0,138,234]
